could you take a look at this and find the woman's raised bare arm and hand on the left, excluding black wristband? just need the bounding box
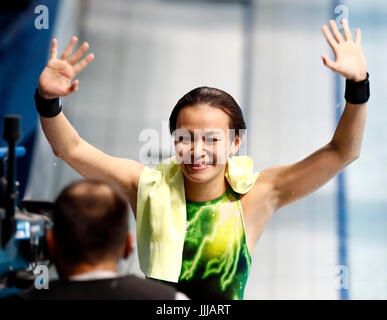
[38,37,144,218]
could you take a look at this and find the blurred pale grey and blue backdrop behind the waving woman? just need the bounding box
[0,0,387,299]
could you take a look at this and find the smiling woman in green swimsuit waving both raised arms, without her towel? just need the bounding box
[35,19,369,299]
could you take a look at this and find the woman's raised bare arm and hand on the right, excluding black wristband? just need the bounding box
[257,20,367,211]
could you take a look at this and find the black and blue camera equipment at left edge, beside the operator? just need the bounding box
[0,115,54,298]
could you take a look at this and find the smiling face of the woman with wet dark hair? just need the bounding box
[175,104,240,182]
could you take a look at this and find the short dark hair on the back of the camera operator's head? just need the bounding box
[53,180,129,264]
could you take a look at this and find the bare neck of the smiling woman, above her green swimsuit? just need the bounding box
[184,174,228,202]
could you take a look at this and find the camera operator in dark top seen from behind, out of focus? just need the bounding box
[18,180,187,300]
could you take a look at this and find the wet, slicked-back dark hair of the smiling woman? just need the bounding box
[169,87,246,135]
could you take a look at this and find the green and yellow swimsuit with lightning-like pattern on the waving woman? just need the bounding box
[152,187,255,300]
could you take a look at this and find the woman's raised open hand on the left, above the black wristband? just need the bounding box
[38,37,94,99]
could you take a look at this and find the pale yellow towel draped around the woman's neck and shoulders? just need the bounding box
[136,156,259,282]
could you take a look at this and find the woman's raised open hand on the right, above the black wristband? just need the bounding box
[321,19,367,81]
